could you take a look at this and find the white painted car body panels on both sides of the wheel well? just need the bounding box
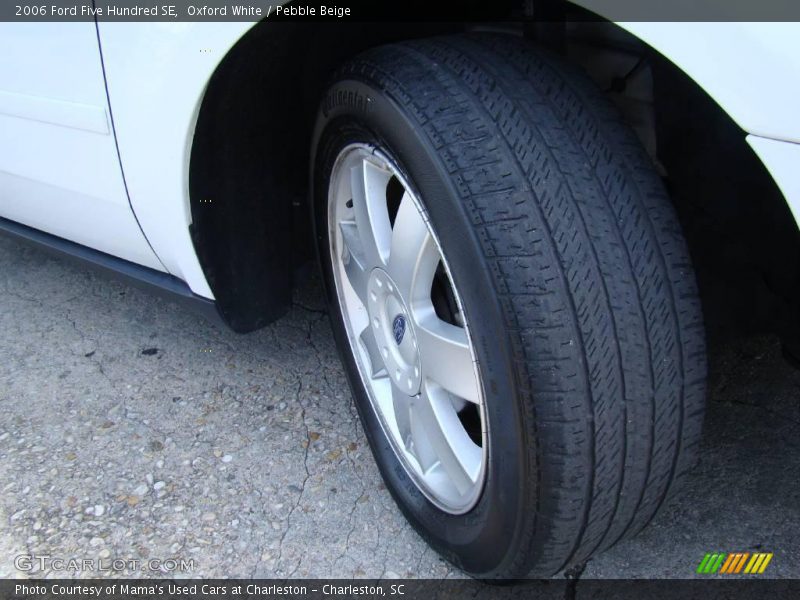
[0,16,800,299]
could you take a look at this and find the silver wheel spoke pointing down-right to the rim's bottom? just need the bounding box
[412,385,481,494]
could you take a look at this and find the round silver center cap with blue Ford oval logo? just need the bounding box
[367,269,420,396]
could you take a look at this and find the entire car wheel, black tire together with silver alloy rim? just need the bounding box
[312,35,705,578]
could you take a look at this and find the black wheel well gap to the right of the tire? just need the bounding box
[564,21,800,343]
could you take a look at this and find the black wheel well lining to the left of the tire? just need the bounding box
[189,22,459,332]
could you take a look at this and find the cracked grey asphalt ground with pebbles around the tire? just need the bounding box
[0,238,800,578]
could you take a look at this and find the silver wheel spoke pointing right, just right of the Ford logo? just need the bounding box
[416,306,481,403]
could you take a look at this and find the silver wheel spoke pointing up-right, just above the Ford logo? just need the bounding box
[388,193,440,303]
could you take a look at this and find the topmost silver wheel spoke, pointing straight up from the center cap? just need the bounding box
[350,159,392,272]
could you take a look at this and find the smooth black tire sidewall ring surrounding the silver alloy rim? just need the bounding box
[311,79,535,577]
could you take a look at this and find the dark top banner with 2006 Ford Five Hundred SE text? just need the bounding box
[0,0,800,23]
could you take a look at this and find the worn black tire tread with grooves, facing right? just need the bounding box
[339,34,706,576]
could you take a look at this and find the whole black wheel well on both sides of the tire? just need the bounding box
[189,17,800,337]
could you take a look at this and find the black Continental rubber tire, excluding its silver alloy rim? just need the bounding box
[312,34,706,578]
